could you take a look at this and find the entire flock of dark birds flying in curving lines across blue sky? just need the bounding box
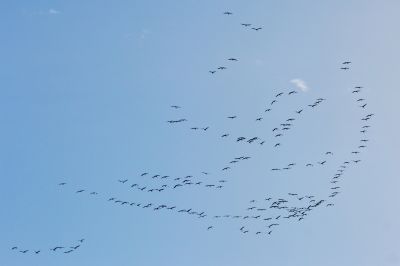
[12,8,374,254]
